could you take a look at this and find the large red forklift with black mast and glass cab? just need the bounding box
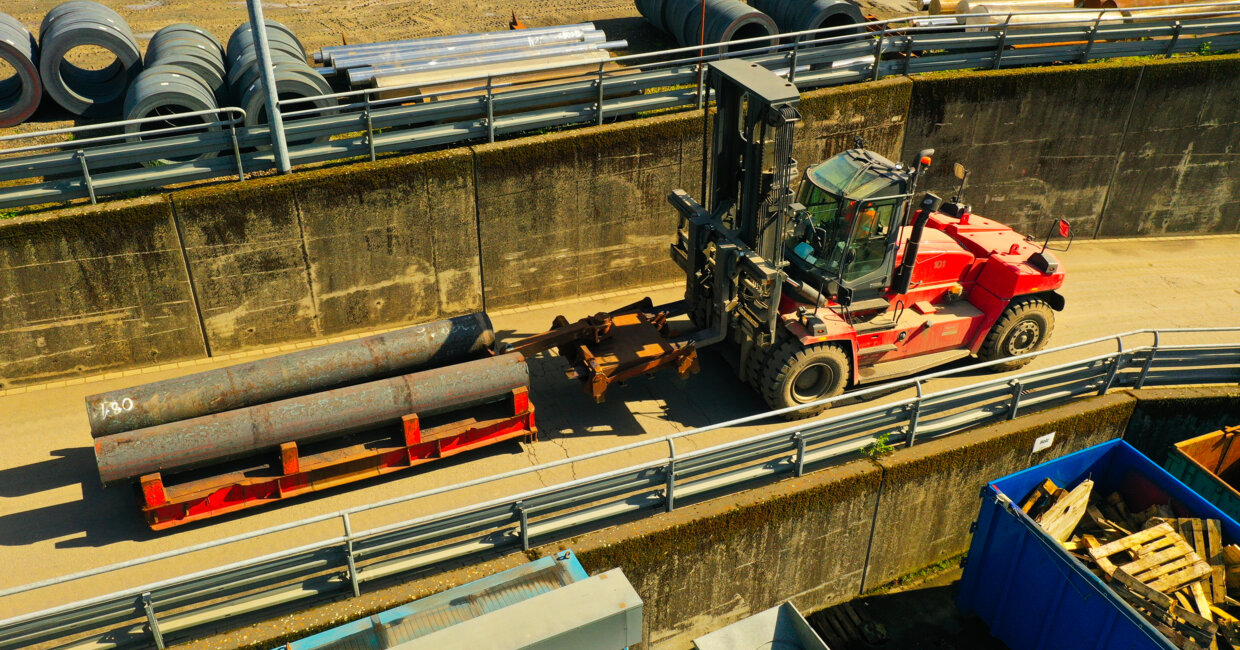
[655,60,1071,418]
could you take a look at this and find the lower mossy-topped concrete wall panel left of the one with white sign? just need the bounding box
[577,461,882,648]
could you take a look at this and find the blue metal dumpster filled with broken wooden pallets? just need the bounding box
[957,440,1240,650]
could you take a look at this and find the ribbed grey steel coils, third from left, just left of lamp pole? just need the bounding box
[124,24,227,166]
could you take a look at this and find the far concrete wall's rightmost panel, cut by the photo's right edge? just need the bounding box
[1084,56,1240,237]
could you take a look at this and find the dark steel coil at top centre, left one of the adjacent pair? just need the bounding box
[637,0,779,47]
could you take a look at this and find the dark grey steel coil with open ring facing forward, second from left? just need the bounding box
[38,0,143,117]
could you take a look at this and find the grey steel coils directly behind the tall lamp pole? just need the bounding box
[226,20,336,133]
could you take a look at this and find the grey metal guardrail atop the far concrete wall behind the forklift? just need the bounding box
[0,1,1240,208]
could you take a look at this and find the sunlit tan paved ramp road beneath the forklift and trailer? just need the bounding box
[0,236,1240,618]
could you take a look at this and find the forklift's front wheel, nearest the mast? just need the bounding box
[763,339,852,419]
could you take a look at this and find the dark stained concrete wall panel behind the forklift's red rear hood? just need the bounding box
[901,65,1141,238]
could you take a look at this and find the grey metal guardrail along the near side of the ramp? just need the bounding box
[0,327,1240,649]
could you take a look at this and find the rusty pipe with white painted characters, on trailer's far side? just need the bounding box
[86,313,495,438]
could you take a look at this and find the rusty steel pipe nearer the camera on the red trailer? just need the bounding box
[94,354,529,485]
